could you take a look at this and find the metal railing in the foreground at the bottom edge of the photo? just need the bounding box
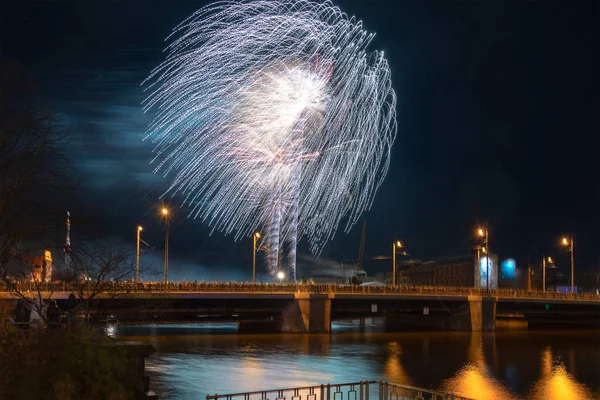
[206,381,470,400]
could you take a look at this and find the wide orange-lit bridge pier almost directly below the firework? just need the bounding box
[281,293,331,333]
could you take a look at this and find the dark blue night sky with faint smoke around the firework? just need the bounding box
[0,0,600,280]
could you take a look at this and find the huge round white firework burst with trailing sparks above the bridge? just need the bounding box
[144,0,396,278]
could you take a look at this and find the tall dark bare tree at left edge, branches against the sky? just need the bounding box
[0,60,73,282]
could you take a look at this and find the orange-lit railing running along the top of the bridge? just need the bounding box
[0,282,600,301]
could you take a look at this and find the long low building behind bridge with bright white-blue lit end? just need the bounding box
[388,253,498,289]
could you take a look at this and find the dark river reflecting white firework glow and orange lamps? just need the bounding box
[113,323,600,400]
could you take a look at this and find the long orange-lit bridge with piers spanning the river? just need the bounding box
[0,282,600,333]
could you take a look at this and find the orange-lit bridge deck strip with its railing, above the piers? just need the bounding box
[0,282,600,304]
